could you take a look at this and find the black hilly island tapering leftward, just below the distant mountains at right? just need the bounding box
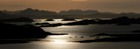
[63,16,140,25]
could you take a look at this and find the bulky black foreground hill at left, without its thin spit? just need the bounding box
[0,23,52,39]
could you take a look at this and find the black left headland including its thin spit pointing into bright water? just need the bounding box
[0,23,67,44]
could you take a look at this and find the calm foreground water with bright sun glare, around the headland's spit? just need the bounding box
[0,24,140,49]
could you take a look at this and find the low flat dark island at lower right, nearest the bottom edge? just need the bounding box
[74,33,140,43]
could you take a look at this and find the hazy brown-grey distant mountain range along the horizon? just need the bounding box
[0,8,140,19]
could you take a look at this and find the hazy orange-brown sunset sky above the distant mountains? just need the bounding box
[0,0,140,13]
